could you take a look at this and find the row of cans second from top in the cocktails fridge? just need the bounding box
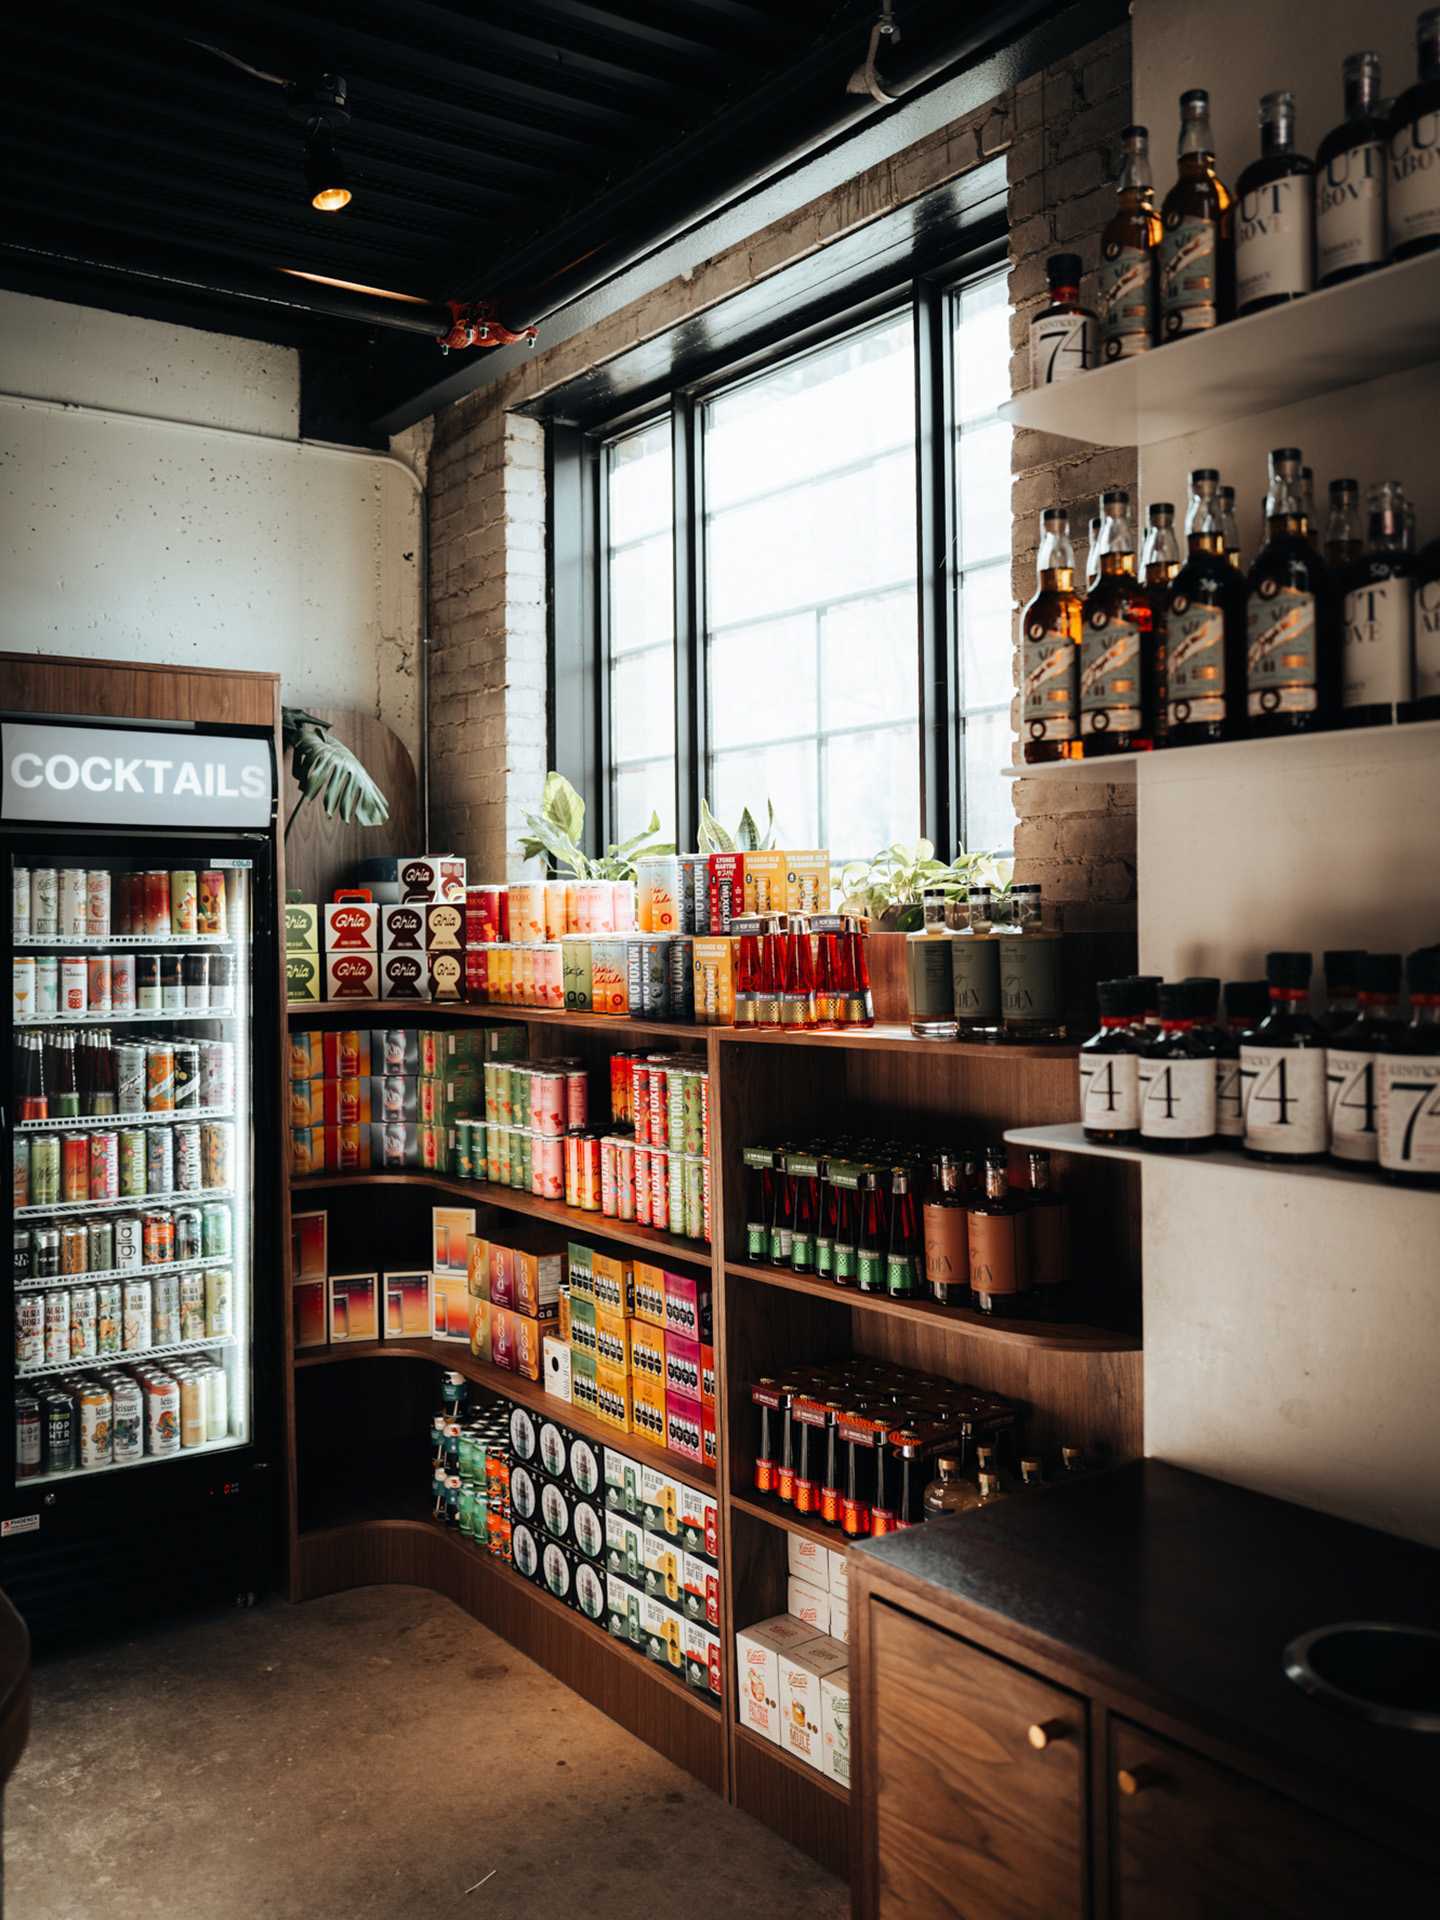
[12,952,234,1020]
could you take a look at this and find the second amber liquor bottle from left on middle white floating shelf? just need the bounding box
[1081,488,1156,760]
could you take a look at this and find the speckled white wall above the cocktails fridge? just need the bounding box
[0,292,419,755]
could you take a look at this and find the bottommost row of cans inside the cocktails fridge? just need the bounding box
[15,1359,230,1480]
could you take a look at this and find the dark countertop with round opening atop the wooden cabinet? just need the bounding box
[852,1461,1440,1826]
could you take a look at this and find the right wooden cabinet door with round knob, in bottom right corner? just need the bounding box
[1108,1718,1434,1920]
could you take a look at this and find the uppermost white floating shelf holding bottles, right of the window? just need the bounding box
[1000,253,1440,447]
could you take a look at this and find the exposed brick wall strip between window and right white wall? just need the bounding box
[1006,27,1139,933]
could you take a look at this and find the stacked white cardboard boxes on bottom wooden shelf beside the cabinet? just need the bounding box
[735,1534,851,1788]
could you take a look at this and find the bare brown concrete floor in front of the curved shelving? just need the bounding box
[4,1586,849,1920]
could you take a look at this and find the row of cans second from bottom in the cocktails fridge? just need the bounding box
[15,1267,234,1373]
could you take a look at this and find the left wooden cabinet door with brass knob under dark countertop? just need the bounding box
[864,1599,1087,1920]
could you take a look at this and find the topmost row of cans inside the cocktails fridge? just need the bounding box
[12,866,230,947]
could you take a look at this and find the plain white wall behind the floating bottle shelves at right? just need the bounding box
[1133,0,1440,1546]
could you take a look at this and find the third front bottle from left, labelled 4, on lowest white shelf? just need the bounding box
[1240,952,1329,1165]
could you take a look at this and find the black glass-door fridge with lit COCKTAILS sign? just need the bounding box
[0,716,282,1638]
